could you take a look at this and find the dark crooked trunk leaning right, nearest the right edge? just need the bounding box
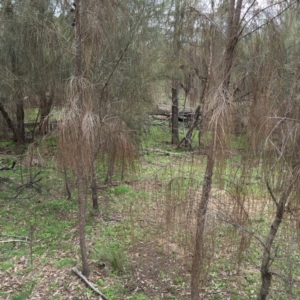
[257,174,297,300]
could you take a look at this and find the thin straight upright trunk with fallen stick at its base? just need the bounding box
[75,0,90,277]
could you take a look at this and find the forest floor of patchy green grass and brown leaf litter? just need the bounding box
[0,126,300,300]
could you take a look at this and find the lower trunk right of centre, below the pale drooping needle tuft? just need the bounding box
[191,128,216,300]
